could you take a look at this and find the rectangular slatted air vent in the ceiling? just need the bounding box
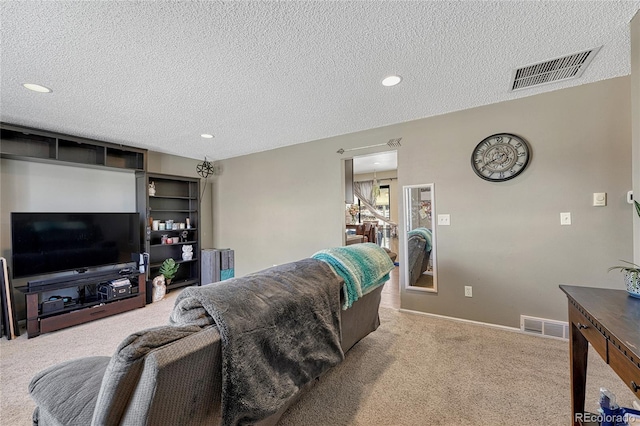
[511,46,602,91]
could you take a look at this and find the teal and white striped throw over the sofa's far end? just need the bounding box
[311,243,394,309]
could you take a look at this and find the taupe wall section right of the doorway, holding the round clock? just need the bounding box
[399,78,632,327]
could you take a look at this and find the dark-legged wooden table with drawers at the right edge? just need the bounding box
[560,285,640,426]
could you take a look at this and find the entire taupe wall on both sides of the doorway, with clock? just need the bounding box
[213,77,633,327]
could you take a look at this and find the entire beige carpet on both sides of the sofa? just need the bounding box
[0,292,634,426]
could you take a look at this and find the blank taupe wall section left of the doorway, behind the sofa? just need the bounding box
[213,142,345,276]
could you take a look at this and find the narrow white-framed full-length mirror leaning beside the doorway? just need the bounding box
[402,183,438,292]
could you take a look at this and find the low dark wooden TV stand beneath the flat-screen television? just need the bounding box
[22,269,146,338]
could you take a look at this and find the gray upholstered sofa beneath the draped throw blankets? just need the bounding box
[29,261,382,426]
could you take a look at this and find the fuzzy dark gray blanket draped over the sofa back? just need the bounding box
[171,259,344,425]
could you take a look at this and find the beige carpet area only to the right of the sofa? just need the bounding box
[279,309,634,426]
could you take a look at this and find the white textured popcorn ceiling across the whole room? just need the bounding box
[0,1,640,160]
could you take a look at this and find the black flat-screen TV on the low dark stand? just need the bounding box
[11,213,140,278]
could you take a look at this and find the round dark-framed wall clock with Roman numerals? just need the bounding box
[471,133,531,182]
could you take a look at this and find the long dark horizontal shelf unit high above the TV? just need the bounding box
[0,123,147,171]
